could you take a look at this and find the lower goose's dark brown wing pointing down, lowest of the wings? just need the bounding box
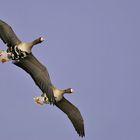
[55,97,85,137]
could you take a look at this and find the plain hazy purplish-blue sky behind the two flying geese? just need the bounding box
[0,0,140,140]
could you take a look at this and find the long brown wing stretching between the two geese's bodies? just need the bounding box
[13,54,55,104]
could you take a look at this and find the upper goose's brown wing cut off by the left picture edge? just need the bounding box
[0,20,21,47]
